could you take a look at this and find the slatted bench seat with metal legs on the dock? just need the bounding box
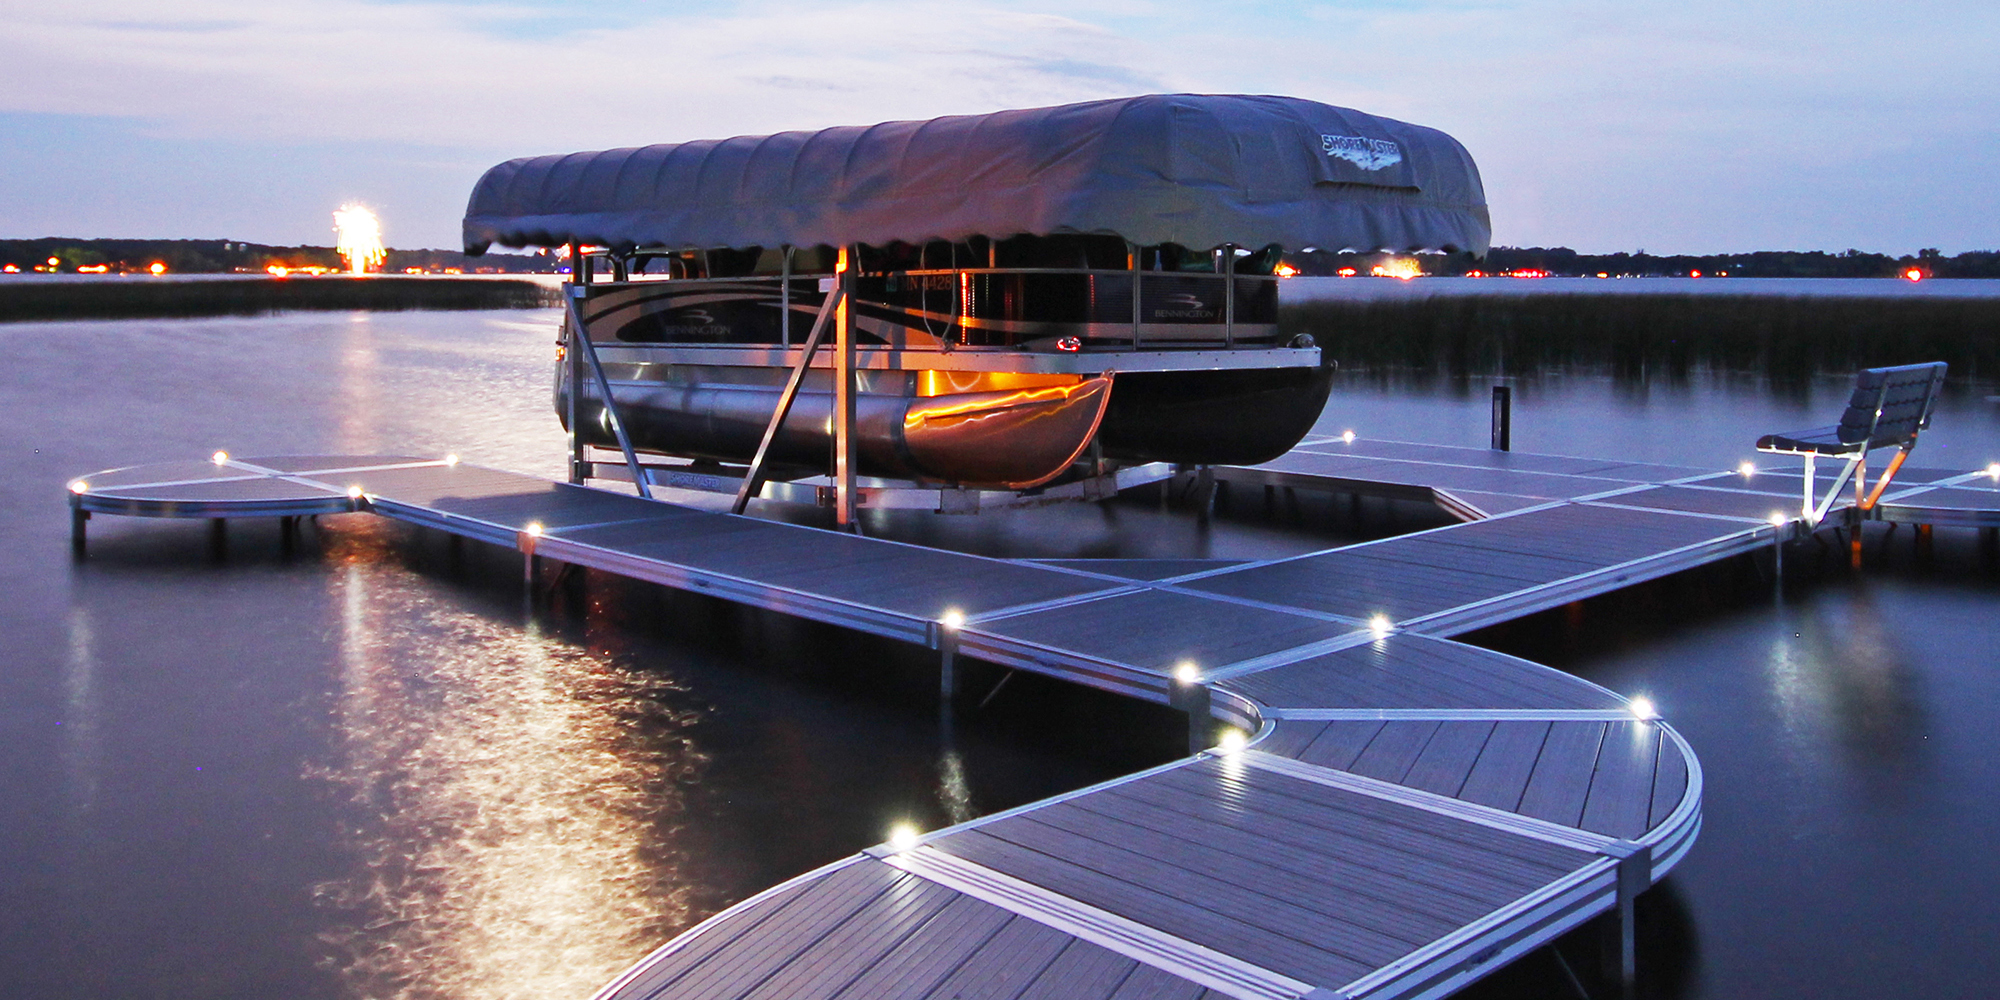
[1756,362,1944,526]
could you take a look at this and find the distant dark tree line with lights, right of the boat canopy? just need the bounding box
[1286,246,2000,278]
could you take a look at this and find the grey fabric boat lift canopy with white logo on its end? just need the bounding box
[464,94,1492,256]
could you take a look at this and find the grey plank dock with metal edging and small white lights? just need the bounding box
[70,436,2000,1000]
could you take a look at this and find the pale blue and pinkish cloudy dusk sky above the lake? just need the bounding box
[0,0,2000,254]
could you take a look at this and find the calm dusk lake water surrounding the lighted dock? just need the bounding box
[0,304,2000,1000]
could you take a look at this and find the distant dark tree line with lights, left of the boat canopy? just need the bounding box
[0,236,556,274]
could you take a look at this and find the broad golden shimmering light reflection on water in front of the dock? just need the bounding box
[316,532,704,1000]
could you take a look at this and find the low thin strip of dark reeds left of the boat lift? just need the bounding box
[0,276,562,322]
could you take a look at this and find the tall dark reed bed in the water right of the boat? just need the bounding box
[1278,294,2000,388]
